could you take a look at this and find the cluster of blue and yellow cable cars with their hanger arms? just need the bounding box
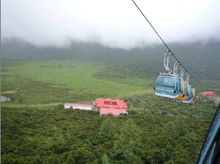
[154,50,195,103]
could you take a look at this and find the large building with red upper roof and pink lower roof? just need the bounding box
[95,98,128,116]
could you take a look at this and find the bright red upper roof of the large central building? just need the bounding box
[95,98,128,110]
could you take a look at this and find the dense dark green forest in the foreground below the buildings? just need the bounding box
[2,95,215,163]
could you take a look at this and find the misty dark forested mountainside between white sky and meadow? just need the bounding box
[1,38,220,80]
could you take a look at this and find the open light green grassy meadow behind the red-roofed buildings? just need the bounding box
[2,61,152,104]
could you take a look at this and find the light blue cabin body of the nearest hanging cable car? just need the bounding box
[154,74,182,99]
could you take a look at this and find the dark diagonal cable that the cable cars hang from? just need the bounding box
[132,0,201,84]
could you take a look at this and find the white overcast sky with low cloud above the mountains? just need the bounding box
[1,0,220,48]
